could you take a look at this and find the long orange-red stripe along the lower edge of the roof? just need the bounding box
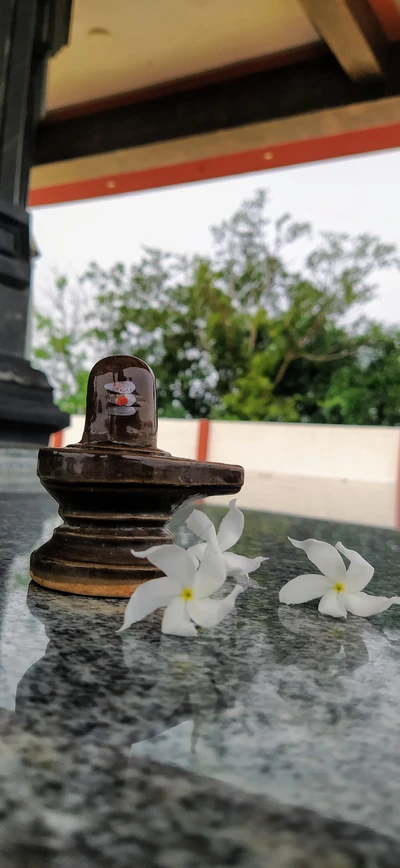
[29,123,400,207]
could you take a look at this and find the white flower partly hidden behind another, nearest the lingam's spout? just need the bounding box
[186,500,266,578]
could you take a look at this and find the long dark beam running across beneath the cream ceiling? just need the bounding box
[35,55,390,171]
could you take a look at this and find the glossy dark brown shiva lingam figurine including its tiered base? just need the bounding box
[31,356,244,597]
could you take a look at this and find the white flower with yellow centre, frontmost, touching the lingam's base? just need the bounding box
[118,543,243,636]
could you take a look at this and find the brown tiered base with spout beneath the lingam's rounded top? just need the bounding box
[31,447,241,597]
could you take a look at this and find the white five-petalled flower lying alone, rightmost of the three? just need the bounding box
[279,537,398,618]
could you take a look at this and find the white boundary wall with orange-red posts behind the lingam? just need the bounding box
[54,416,400,527]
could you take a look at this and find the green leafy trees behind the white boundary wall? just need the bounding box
[35,191,400,425]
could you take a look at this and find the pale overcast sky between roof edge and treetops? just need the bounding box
[33,150,400,323]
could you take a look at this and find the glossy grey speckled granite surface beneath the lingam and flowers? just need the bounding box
[0,494,400,868]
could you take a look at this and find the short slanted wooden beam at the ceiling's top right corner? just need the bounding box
[300,0,387,81]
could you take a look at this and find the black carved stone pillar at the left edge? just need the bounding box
[0,0,72,445]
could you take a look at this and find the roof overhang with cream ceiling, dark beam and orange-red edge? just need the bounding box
[30,0,400,205]
